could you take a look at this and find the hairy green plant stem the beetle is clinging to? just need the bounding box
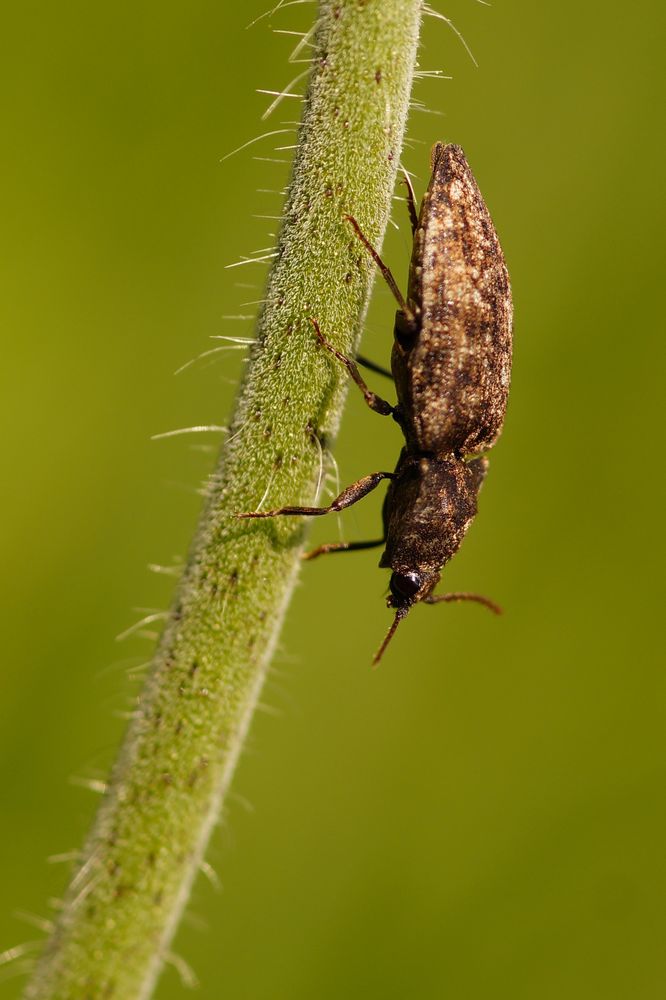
[25,0,421,1000]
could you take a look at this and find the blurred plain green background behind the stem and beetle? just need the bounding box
[0,0,666,1000]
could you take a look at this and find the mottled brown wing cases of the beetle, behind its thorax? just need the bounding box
[391,143,512,457]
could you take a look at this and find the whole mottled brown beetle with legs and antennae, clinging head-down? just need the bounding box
[238,143,512,663]
